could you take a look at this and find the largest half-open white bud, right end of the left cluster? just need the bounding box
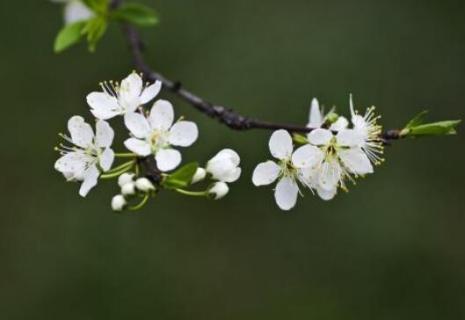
[206,149,241,183]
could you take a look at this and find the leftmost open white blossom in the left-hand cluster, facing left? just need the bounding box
[55,116,114,197]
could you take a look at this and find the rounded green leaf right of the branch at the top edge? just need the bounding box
[112,3,158,27]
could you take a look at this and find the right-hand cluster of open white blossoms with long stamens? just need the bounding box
[252,97,383,210]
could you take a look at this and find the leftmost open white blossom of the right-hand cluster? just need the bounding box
[252,130,323,211]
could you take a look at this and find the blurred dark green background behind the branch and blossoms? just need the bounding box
[0,0,465,320]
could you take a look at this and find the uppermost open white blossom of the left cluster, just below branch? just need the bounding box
[87,72,161,120]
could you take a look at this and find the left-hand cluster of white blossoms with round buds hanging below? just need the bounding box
[55,72,241,211]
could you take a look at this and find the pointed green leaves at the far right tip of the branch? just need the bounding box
[400,111,462,137]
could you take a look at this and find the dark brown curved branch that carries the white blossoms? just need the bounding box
[111,0,401,143]
